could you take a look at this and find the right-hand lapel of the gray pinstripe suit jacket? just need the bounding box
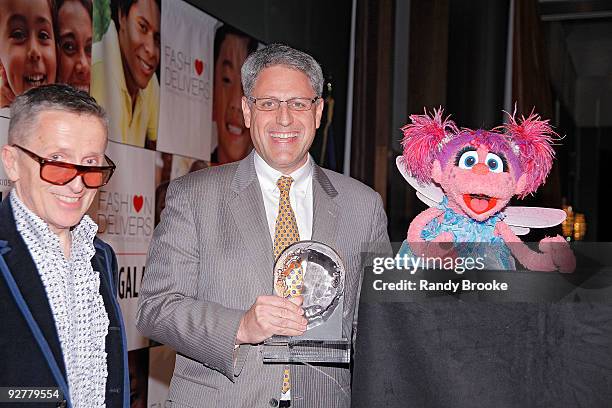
[312,164,340,249]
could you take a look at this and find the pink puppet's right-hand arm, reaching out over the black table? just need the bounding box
[495,221,576,273]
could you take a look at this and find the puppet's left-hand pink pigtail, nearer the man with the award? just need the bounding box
[401,107,458,183]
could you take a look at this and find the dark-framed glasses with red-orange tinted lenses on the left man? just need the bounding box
[13,144,117,188]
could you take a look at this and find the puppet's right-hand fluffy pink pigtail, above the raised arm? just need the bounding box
[503,111,559,198]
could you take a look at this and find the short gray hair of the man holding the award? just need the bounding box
[240,44,323,96]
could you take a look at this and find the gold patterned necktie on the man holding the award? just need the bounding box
[274,176,302,394]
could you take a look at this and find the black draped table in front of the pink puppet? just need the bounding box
[352,245,612,408]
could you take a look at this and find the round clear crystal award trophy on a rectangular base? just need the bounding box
[262,241,350,363]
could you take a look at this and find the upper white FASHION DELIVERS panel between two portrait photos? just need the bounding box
[157,0,217,160]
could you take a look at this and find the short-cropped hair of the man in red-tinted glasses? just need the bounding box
[8,84,108,144]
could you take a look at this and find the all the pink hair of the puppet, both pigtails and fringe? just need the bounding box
[401,108,559,198]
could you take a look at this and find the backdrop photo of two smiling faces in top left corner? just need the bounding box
[0,0,92,108]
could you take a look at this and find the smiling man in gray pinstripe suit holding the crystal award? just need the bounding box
[137,44,390,408]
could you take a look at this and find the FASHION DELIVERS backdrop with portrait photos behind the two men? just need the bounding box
[0,0,261,402]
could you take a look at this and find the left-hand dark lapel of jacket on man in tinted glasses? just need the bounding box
[0,197,66,378]
